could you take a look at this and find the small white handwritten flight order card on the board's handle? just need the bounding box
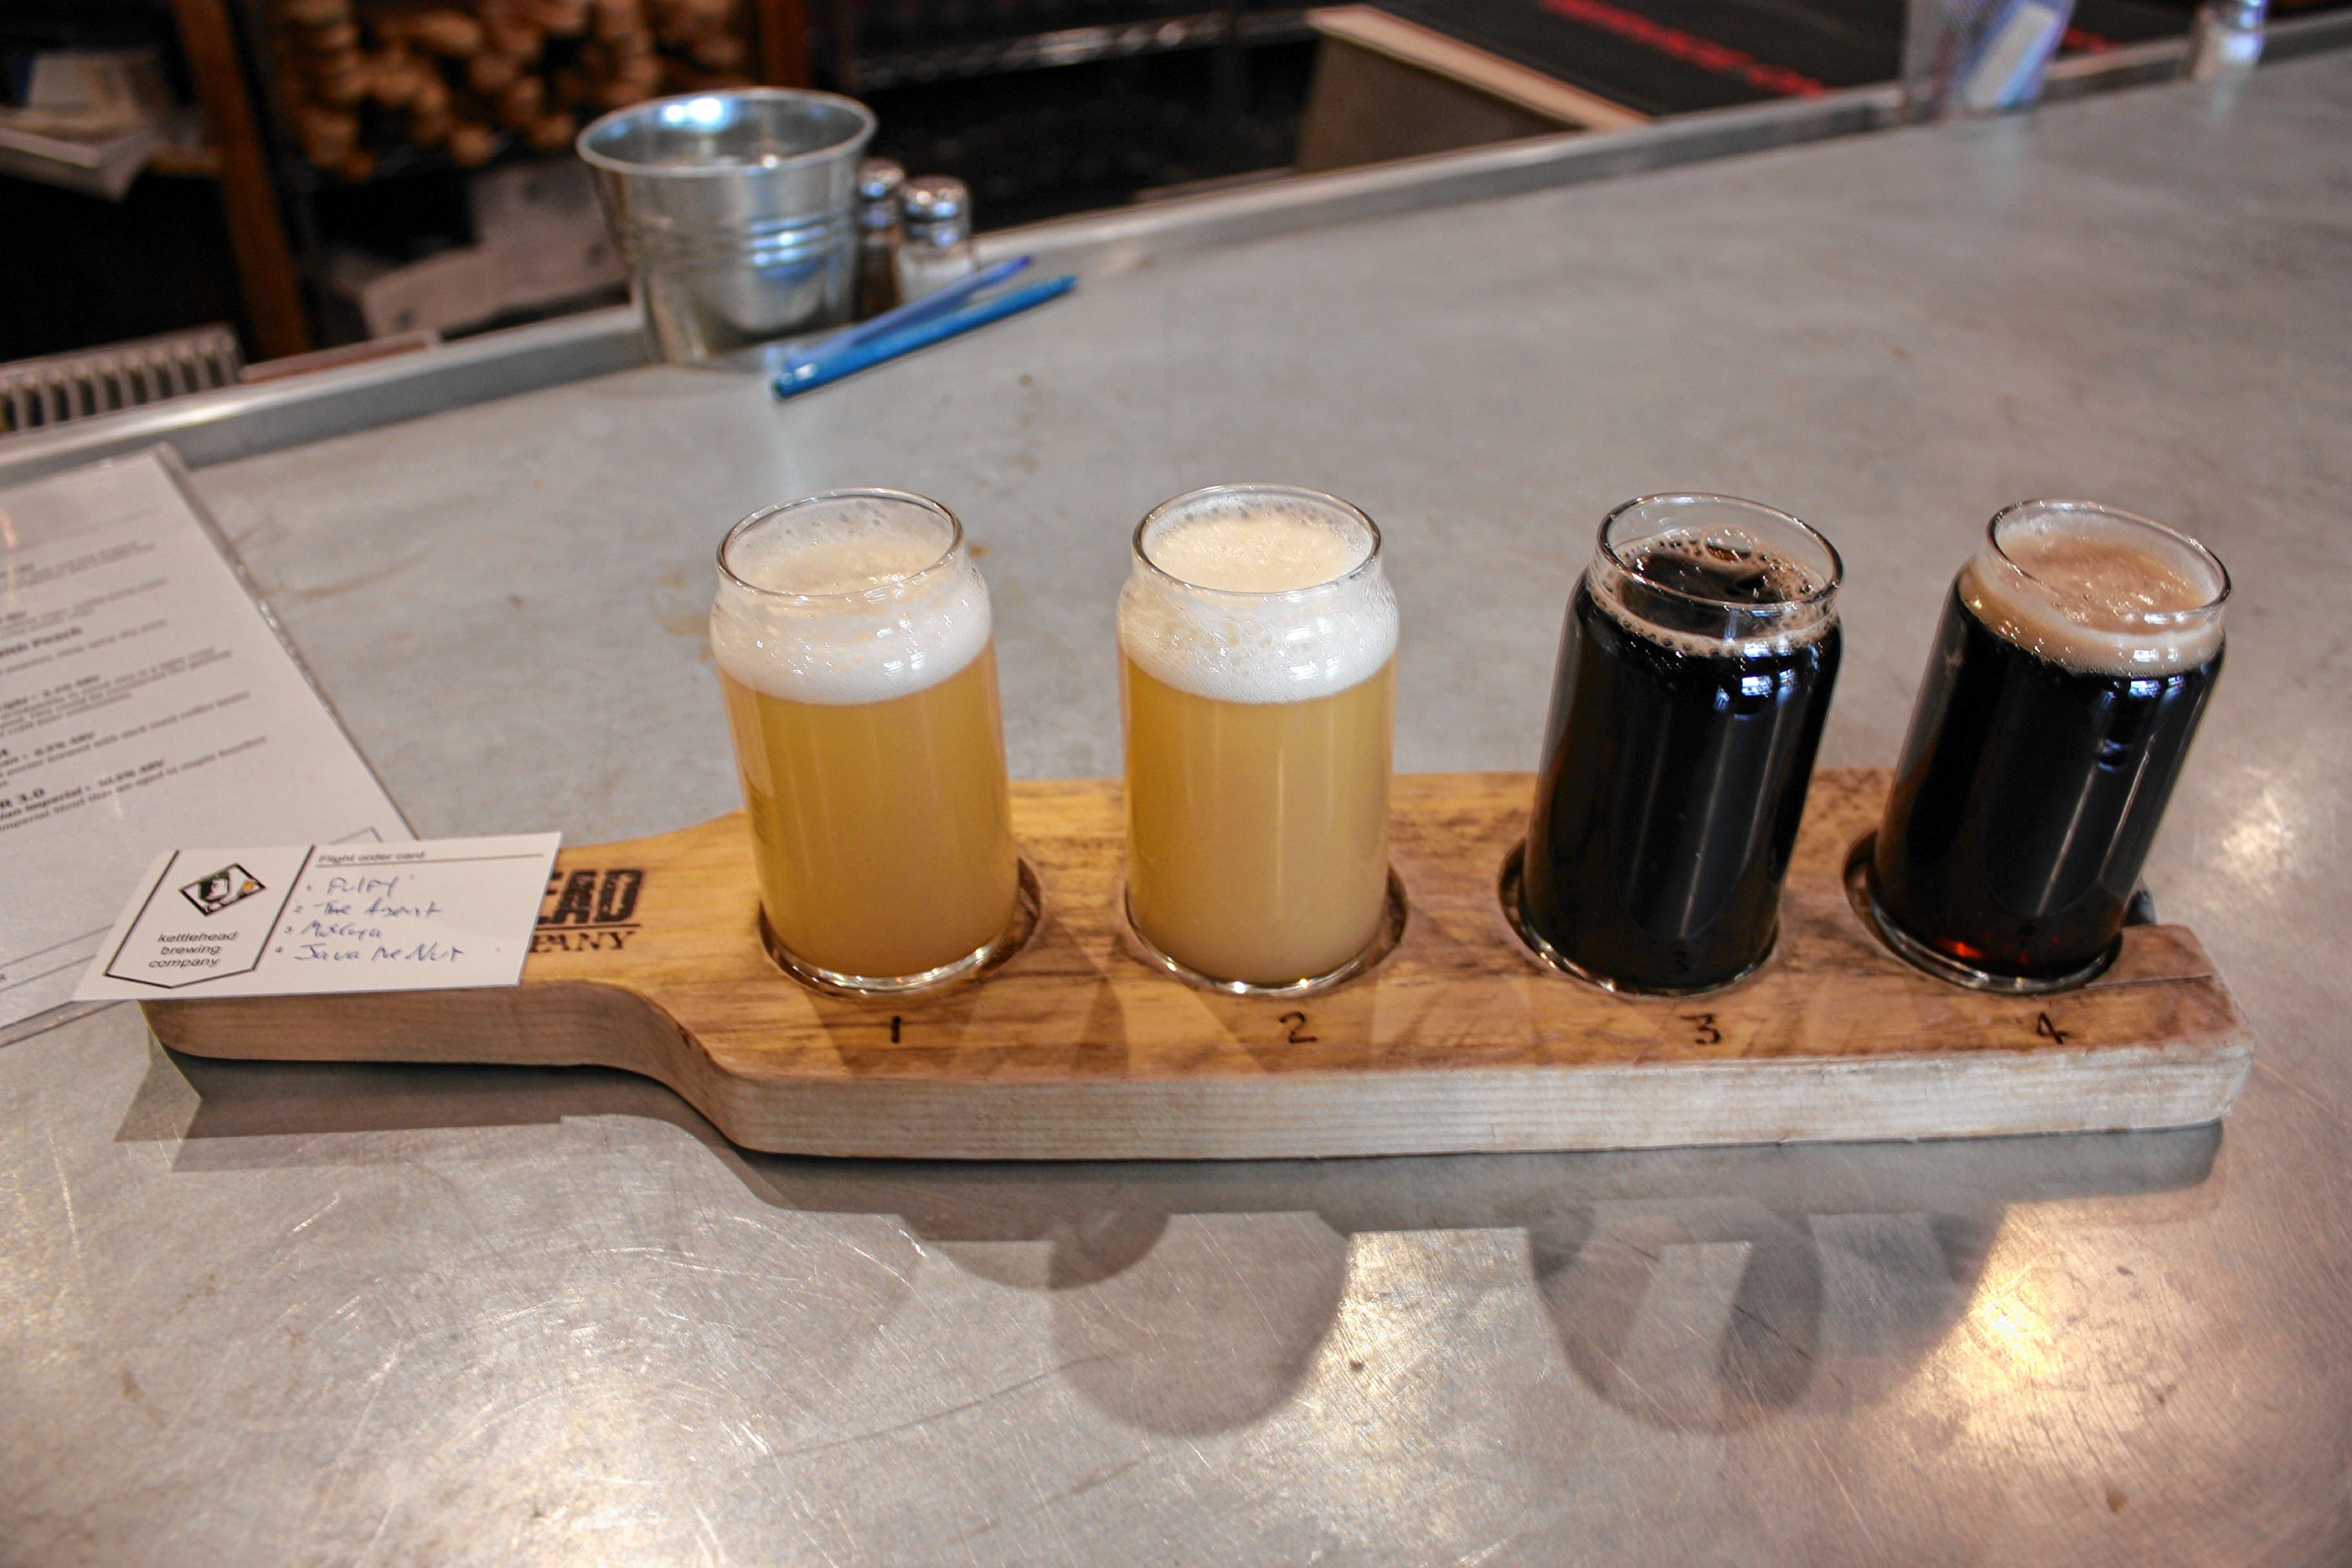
[73,832,557,1001]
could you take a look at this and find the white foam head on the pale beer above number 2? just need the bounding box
[1120,485,1397,703]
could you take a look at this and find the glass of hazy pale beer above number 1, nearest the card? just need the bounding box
[710,489,1021,992]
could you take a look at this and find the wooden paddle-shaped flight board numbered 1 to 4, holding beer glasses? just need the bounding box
[143,769,2253,1159]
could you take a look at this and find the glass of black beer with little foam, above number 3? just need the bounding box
[1517,494,1842,994]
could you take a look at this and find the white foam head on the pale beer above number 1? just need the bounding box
[710,492,990,703]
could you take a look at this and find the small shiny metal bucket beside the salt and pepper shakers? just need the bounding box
[579,87,875,365]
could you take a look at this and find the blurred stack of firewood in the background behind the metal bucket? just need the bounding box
[270,0,750,179]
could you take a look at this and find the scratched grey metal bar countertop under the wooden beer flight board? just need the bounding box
[0,54,2352,1568]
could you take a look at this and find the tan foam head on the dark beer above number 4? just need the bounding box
[1959,501,2230,675]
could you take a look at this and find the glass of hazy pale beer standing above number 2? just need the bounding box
[1120,485,1397,992]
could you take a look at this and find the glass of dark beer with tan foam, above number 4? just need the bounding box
[1867,501,2230,992]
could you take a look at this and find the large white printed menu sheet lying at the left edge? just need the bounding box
[0,452,409,1027]
